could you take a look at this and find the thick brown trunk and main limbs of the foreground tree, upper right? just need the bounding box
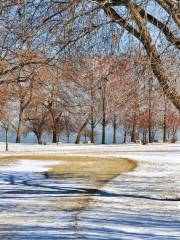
[93,0,180,109]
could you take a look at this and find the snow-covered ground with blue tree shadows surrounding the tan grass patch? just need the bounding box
[0,144,180,240]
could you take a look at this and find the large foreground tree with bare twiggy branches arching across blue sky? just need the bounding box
[3,0,180,109]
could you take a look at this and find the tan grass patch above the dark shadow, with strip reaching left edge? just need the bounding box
[0,155,137,185]
